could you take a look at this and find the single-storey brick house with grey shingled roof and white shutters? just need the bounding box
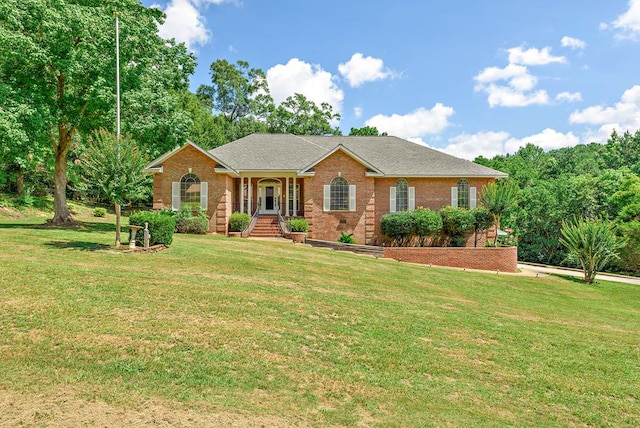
[145,134,507,244]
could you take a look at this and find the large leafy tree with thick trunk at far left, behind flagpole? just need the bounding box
[0,0,194,224]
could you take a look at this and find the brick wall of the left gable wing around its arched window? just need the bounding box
[153,145,233,233]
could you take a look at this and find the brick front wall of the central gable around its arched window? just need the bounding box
[303,150,376,244]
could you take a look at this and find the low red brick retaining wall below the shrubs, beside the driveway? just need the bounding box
[384,247,518,272]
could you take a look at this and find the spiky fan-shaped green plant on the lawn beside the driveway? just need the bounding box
[560,218,624,284]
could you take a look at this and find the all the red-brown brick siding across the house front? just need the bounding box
[153,145,494,245]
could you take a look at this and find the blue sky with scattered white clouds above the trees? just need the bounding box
[143,0,640,159]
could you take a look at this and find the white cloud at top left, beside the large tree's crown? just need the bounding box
[154,0,211,50]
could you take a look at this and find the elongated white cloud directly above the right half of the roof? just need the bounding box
[365,103,454,138]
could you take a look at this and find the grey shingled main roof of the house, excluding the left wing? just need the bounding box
[208,134,508,178]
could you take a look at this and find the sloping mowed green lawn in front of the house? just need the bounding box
[0,220,640,427]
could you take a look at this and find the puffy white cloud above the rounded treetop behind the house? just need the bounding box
[267,58,344,113]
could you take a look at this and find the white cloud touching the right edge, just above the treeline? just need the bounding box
[569,85,640,141]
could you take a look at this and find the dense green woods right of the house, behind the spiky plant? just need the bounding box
[475,131,640,275]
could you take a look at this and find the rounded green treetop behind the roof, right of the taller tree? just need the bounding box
[268,94,341,135]
